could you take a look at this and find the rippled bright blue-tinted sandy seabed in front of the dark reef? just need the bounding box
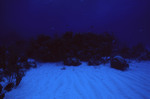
[5,62,150,99]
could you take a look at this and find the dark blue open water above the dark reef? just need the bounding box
[0,0,150,45]
